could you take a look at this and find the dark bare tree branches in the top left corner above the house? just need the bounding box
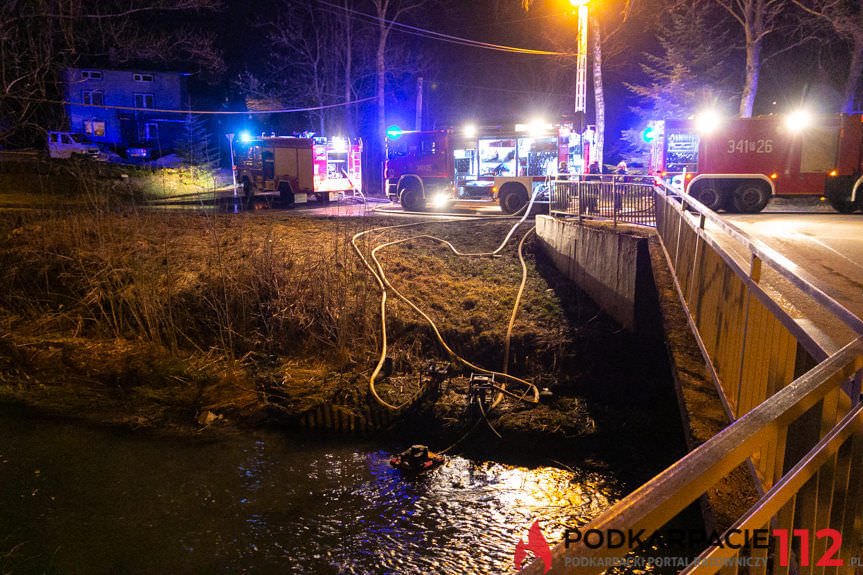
[0,0,223,142]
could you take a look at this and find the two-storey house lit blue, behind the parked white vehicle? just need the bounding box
[63,68,189,158]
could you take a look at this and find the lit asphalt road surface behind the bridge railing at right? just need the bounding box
[725,205,863,351]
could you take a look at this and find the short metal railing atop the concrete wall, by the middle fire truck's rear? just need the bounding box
[550,174,656,226]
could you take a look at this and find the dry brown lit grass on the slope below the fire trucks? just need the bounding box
[0,200,566,425]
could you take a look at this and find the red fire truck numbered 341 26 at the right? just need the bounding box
[649,113,863,213]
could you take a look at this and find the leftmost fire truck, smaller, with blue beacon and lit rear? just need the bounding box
[235,136,363,207]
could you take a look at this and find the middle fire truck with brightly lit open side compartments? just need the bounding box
[385,122,589,214]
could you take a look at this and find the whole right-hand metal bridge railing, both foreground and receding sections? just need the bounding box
[524,183,863,575]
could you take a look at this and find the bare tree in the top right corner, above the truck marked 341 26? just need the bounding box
[793,0,863,114]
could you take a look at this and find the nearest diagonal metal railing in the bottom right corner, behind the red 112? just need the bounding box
[522,338,863,575]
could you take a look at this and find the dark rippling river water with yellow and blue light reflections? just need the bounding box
[0,413,619,573]
